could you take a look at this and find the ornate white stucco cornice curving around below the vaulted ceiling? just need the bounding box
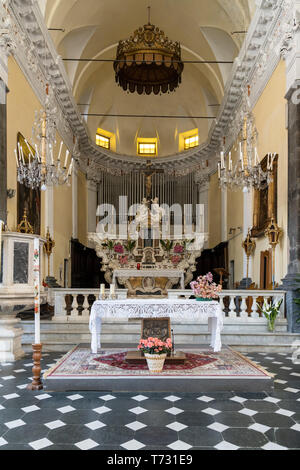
[0,0,299,180]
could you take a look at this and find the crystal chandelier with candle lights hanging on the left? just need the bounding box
[15,86,74,190]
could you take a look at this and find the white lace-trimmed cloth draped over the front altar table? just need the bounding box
[89,299,223,354]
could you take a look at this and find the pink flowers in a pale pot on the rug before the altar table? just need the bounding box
[138,336,172,374]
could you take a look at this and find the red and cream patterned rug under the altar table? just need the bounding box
[44,345,271,378]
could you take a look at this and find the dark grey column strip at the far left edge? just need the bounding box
[0,78,7,223]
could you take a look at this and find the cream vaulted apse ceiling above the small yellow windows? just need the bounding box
[39,0,255,156]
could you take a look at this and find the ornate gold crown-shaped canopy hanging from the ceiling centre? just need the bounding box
[114,7,184,95]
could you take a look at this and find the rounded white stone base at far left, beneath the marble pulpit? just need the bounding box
[0,316,25,362]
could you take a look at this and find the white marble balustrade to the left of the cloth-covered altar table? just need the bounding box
[49,289,127,321]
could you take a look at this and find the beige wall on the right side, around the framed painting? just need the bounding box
[223,61,288,285]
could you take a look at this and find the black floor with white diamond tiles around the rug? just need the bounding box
[0,353,300,450]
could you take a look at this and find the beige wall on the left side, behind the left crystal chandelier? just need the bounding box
[7,57,72,282]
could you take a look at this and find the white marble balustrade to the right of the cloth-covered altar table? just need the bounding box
[168,289,285,320]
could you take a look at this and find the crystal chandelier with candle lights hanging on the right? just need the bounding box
[218,86,276,190]
